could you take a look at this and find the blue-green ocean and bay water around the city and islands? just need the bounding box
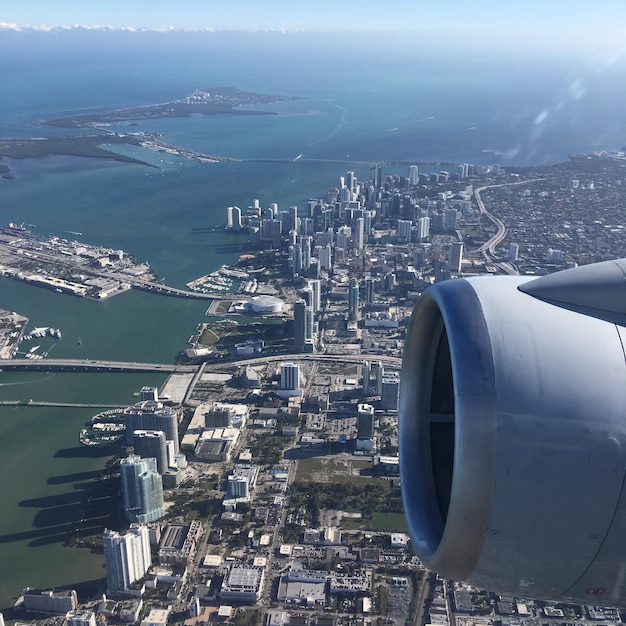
[0,33,626,608]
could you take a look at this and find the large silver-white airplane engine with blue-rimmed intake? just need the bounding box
[399,260,626,606]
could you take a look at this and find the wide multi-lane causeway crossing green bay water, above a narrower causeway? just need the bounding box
[0,359,198,374]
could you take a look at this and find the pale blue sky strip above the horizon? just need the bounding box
[0,0,626,34]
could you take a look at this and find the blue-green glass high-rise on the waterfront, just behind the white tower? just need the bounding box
[120,454,165,524]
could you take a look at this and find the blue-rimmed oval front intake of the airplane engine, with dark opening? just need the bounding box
[399,279,496,580]
